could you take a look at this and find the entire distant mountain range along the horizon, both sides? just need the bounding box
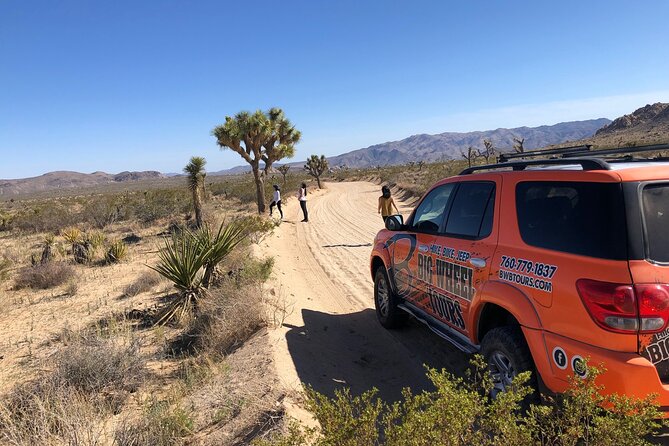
[5,102,669,198]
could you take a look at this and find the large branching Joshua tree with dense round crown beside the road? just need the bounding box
[212,108,302,214]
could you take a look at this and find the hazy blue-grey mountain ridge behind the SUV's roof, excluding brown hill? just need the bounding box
[328,118,611,167]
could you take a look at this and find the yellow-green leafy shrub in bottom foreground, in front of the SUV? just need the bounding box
[256,358,660,446]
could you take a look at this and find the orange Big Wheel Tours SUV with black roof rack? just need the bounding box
[371,145,669,406]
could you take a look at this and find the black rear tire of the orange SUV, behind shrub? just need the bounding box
[481,326,539,404]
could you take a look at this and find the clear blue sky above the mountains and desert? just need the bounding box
[0,0,669,178]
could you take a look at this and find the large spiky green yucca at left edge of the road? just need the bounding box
[149,220,248,324]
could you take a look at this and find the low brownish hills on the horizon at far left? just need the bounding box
[0,171,163,197]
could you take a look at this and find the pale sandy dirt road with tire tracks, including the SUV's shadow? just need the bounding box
[261,182,468,414]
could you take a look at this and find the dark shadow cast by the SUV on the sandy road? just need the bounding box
[286,309,470,401]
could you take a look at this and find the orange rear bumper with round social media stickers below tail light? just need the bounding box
[523,329,669,417]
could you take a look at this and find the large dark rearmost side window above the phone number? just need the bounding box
[516,181,627,260]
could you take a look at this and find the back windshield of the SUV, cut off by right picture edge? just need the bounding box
[641,183,669,263]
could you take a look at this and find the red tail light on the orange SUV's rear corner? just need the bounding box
[576,279,669,333]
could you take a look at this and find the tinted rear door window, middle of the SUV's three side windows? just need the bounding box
[446,181,495,239]
